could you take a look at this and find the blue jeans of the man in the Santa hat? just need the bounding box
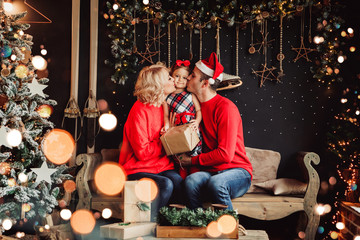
[185,168,251,209]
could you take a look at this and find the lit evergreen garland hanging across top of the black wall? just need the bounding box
[104,0,343,84]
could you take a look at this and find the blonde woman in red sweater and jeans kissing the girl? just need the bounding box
[119,65,182,220]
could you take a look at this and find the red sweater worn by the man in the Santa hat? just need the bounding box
[191,94,252,176]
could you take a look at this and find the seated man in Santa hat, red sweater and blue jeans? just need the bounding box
[179,53,252,209]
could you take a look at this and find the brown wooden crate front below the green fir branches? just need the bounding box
[156,225,239,239]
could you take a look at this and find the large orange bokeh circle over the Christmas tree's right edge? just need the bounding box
[42,128,75,165]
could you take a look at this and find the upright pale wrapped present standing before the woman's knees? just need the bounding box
[122,181,151,222]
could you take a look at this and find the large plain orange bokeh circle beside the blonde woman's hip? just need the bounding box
[94,162,126,196]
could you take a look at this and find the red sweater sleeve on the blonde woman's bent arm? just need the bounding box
[125,105,163,161]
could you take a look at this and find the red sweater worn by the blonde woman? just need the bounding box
[119,101,174,175]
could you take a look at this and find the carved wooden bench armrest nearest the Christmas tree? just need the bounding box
[75,153,102,209]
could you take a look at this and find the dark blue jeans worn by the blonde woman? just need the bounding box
[127,170,183,220]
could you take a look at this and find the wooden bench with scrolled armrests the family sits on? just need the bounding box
[76,147,320,240]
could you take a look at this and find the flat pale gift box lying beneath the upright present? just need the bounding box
[100,222,156,239]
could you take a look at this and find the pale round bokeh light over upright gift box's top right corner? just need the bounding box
[135,178,159,202]
